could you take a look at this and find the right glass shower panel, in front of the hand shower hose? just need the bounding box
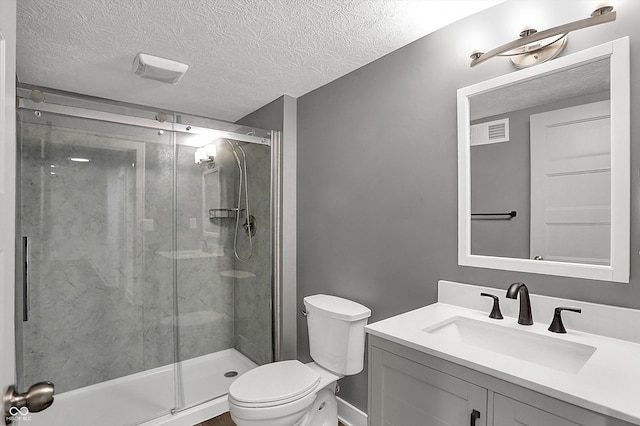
[175,125,273,408]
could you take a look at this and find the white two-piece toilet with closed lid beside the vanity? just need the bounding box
[229,294,371,426]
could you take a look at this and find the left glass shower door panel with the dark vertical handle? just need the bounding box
[17,110,175,424]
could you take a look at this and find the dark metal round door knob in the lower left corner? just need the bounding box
[2,382,55,425]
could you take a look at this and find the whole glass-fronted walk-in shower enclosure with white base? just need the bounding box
[16,88,279,426]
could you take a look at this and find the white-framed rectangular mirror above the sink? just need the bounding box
[458,37,630,282]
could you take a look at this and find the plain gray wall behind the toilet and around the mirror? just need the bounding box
[297,0,640,410]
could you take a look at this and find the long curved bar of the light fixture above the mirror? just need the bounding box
[471,7,616,67]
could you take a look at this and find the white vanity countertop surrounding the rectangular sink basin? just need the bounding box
[366,282,640,424]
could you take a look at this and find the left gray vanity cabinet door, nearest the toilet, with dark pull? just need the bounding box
[369,347,488,426]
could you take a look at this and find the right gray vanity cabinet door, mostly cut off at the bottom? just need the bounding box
[493,394,596,426]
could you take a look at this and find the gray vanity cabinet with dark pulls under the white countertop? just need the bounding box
[368,334,630,426]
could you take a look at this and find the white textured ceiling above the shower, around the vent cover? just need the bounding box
[17,0,500,121]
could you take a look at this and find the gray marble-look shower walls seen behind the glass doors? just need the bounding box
[20,115,271,393]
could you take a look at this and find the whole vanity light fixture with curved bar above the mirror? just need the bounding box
[470,5,616,68]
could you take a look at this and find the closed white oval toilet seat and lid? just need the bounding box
[229,360,320,408]
